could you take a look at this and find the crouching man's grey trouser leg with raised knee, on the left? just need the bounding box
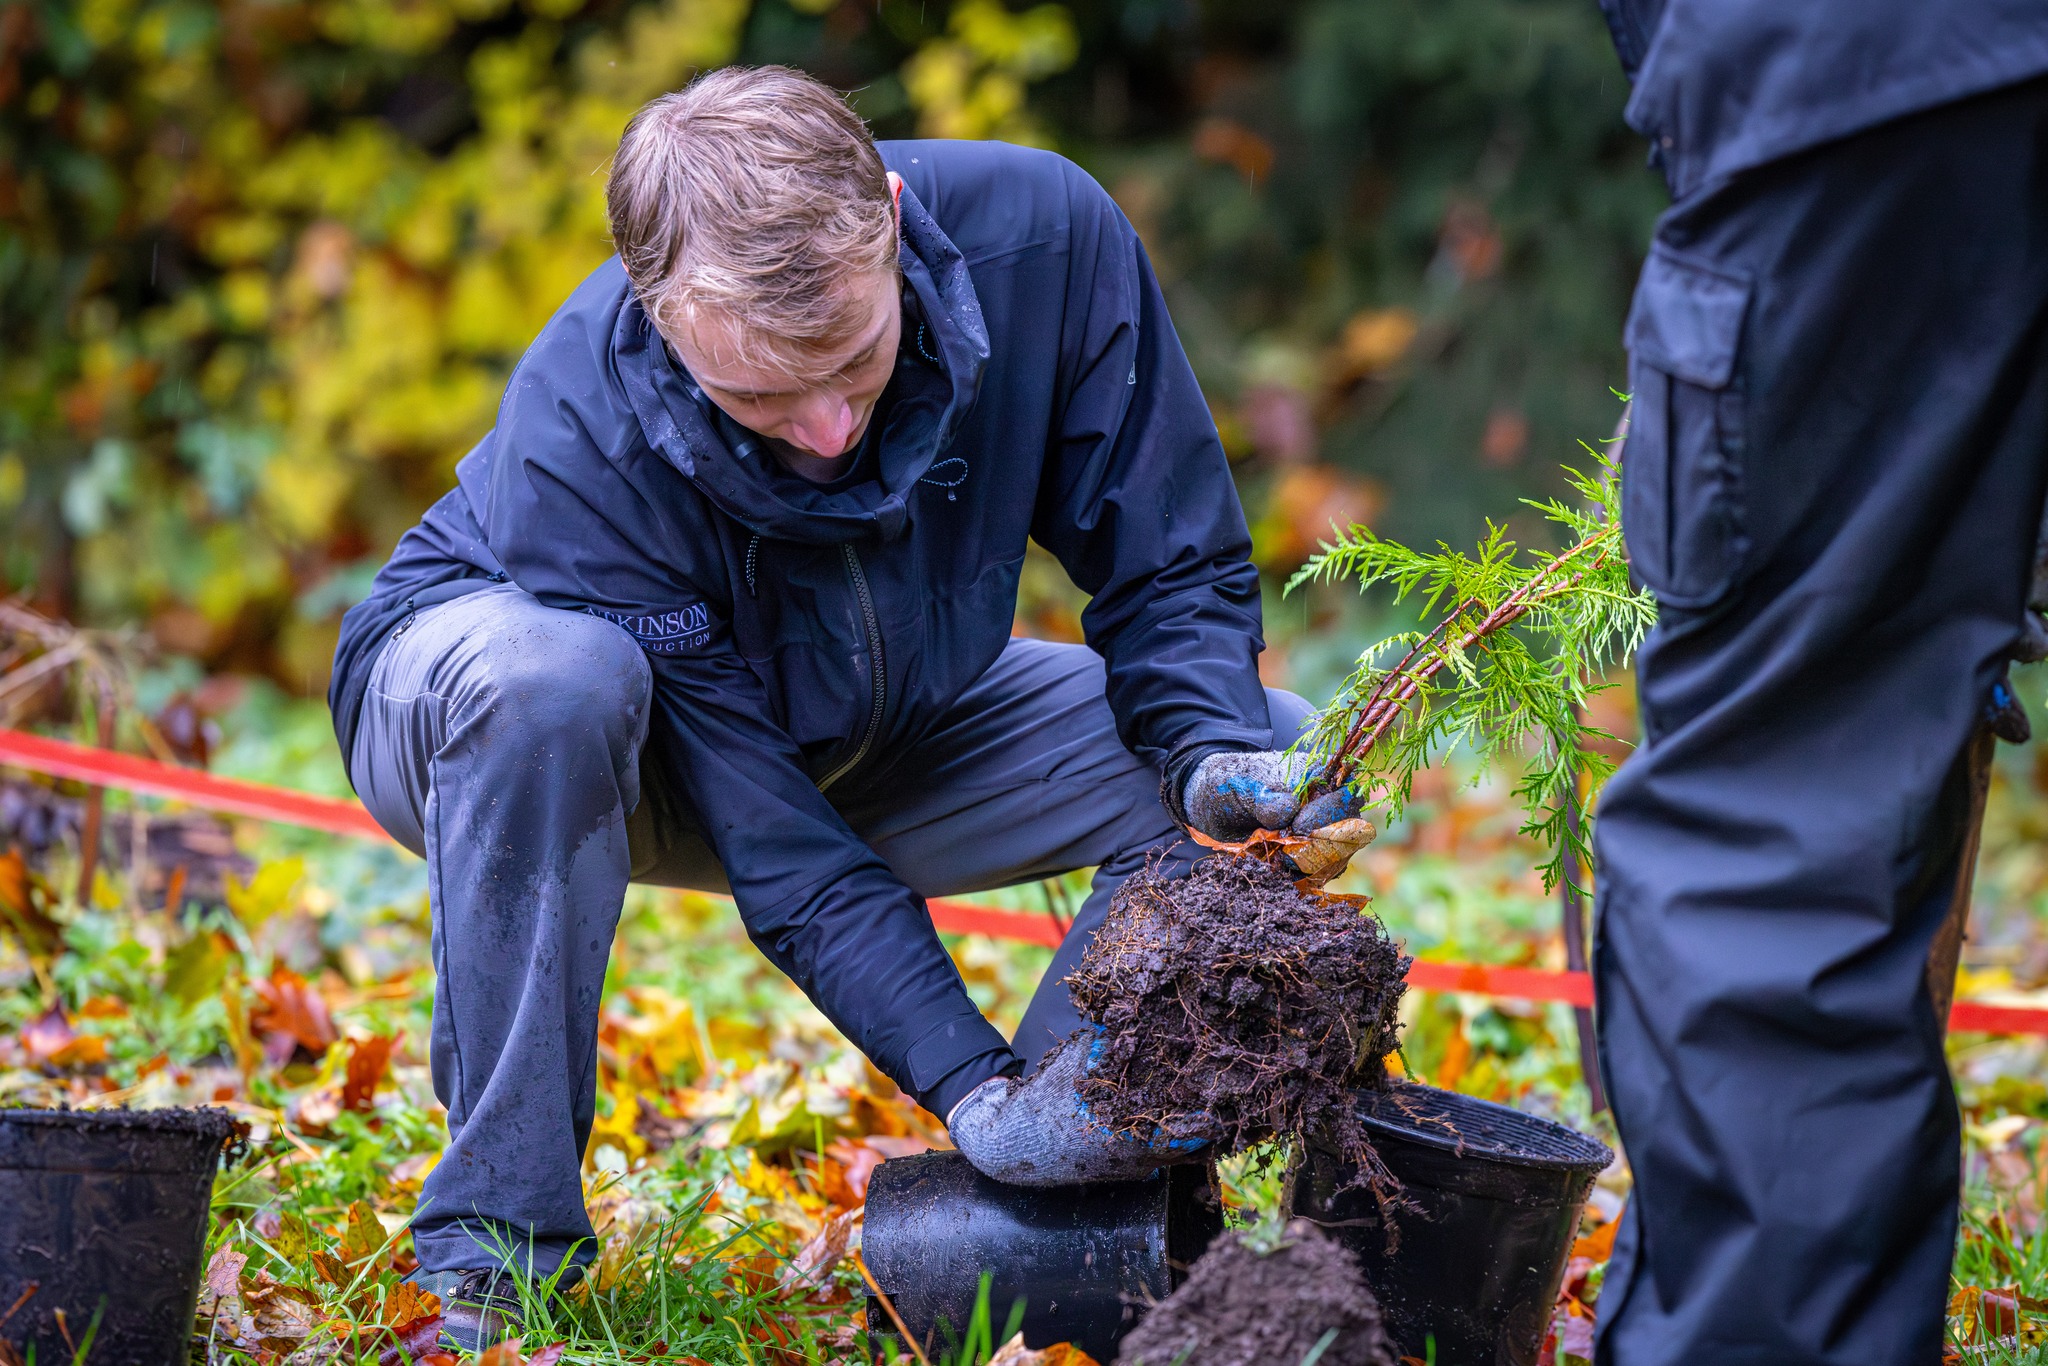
[350,586,651,1274]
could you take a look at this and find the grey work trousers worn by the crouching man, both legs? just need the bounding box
[350,584,1309,1274]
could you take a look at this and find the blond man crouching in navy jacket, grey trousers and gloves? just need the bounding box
[332,68,1348,1348]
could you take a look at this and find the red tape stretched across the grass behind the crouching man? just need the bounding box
[0,729,2048,1034]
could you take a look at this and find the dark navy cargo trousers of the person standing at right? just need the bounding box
[1593,82,2048,1366]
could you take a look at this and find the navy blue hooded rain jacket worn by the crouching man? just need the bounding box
[332,141,1272,1096]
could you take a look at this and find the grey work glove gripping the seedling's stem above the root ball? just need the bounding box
[1180,750,1378,883]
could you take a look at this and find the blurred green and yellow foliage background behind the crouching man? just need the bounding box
[0,0,1661,692]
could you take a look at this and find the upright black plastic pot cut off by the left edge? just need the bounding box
[0,1110,236,1366]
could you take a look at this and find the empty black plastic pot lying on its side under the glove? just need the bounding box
[860,1153,1223,1362]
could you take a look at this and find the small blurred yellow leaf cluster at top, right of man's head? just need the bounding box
[903,0,1079,147]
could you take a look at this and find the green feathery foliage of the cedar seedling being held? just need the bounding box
[1288,442,1657,887]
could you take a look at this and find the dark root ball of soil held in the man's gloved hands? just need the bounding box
[1067,854,1409,1198]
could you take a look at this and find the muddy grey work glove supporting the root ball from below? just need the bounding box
[946,1026,1206,1186]
